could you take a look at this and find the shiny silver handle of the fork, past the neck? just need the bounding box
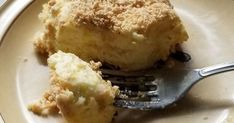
[199,62,234,77]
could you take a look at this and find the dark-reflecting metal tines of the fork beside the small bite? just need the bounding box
[102,70,158,105]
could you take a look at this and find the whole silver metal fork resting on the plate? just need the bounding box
[102,62,234,110]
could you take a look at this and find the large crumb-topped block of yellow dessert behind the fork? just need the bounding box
[35,0,188,70]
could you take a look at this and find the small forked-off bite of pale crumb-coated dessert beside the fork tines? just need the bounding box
[29,51,118,123]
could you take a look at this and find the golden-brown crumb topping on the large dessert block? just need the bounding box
[49,0,176,34]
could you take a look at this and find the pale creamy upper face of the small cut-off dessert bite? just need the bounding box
[48,51,101,86]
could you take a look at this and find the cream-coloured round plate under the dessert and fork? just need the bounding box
[0,0,234,123]
